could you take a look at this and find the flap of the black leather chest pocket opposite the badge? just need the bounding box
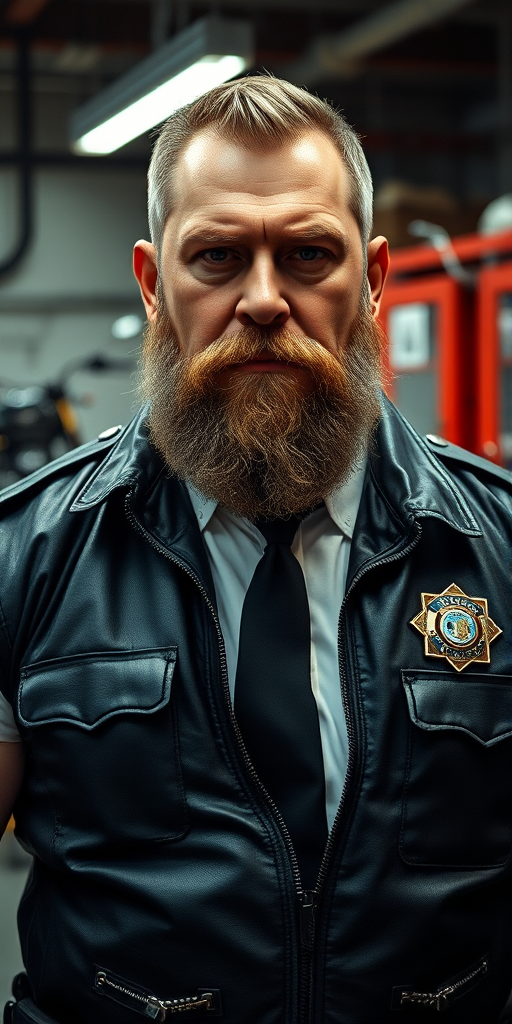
[18,647,176,729]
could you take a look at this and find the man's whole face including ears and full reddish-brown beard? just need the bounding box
[134,125,387,519]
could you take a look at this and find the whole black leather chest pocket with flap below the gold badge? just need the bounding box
[399,670,512,868]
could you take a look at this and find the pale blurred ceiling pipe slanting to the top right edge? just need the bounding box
[280,0,473,85]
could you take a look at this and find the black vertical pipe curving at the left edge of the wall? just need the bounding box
[0,32,34,276]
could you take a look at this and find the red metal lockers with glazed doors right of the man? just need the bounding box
[381,231,512,458]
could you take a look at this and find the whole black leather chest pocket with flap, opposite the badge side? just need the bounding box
[17,647,187,857]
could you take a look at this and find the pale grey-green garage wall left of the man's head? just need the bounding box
[0,163,147,440]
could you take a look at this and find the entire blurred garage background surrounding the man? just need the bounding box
[0,0,512,1006]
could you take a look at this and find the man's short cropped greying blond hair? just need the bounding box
[147,75,373,255]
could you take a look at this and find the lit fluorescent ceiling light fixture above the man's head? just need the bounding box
[71,15,253,156]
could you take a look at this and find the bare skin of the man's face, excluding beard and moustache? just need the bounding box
[136,131,380,373]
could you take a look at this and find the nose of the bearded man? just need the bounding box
[234,256,290,327]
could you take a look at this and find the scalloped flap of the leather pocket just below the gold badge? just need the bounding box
[401,670,512,746]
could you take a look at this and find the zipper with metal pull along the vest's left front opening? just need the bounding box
[125,490,303,1024]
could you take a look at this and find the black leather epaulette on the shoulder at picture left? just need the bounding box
[0,426,123,519]
